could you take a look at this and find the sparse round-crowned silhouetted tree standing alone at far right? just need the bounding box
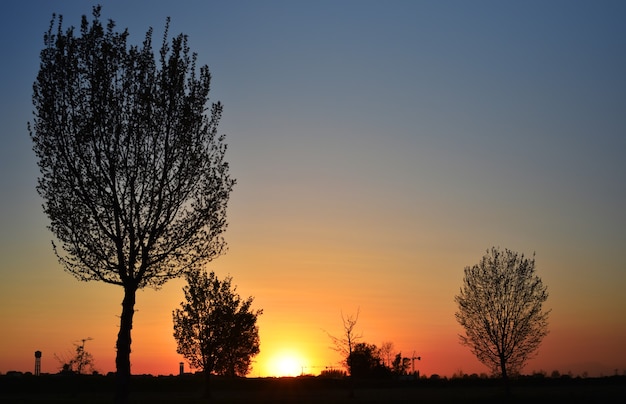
[455,247,549,392]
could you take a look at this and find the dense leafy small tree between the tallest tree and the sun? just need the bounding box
[173,269,263,397]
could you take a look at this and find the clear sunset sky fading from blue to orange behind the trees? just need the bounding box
[0,0,626,376]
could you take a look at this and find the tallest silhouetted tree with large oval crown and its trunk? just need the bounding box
[29,6,234,402]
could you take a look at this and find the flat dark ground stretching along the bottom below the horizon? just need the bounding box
[0,374,626,404]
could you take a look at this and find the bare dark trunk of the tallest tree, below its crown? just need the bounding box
[115,286,137,404]
